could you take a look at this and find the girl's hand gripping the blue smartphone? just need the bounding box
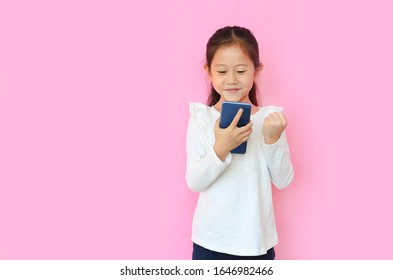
[213,109,252,161]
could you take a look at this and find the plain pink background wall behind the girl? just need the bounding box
[0,0,393,259]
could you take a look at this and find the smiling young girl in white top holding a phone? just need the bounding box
[186,26,293,259]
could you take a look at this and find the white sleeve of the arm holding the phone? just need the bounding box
[186,104,232,192]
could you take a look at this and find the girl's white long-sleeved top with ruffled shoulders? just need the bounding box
[186,103,293,256]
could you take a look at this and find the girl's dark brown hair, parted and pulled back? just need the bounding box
[206,26,262,106]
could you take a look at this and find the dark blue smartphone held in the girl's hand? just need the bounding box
[220,101,251,154]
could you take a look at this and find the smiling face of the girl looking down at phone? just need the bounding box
[205,46,257,104]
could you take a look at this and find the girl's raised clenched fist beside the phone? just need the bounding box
[263,112,288,144]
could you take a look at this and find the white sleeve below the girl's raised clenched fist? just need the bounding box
[262,131,294,189]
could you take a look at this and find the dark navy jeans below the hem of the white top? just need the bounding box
[192,243,276,260]
